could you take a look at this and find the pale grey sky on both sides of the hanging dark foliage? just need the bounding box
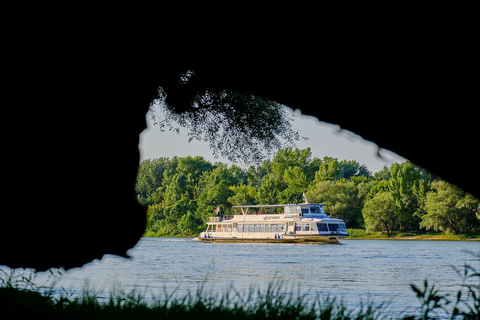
[138,109,406,173]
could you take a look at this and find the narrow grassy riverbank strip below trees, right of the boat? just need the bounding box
[346,229,480,241]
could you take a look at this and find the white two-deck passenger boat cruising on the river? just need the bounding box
[198,203,348,243]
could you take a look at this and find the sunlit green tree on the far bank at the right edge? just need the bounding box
[420,181,480,234]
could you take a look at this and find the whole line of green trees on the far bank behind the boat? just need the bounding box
[135,148,480,236]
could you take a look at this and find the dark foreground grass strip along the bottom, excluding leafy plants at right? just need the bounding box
[0,284,381,320]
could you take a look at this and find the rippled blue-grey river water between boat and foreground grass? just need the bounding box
[8,238,480,315]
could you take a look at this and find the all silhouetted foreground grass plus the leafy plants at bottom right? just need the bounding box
[0,253,480,320]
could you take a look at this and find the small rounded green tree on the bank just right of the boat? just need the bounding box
[362,192,398,237]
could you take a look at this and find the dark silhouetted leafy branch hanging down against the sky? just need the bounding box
[150,71,305,164]
